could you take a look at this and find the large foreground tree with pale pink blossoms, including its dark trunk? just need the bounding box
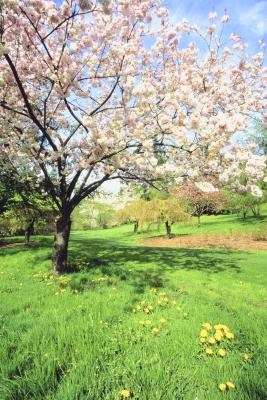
[0,0,265,273]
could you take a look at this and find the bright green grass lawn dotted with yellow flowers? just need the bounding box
[0,216,267,400]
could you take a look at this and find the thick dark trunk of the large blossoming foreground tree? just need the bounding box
[52,215,71,274]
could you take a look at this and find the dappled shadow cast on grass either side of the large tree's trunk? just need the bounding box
[0,235,244,293]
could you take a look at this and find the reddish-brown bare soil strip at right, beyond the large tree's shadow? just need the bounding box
[142,233,267,251]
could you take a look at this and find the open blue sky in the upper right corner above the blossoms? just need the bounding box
[168,0,267,51]
